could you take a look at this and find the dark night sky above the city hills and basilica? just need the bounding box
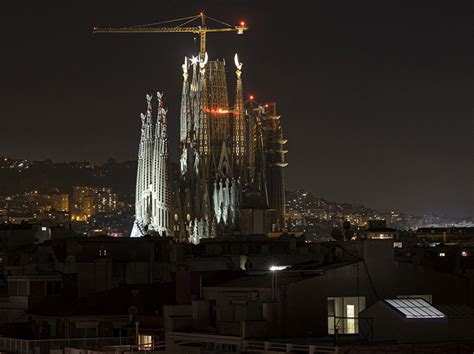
[0,0,474,216]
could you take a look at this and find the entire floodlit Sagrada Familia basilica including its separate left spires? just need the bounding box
[131,53,287,244]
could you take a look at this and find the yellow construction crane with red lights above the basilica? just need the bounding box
[93,12,248,59]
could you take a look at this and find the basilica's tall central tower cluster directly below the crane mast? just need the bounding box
[176,53,240,243]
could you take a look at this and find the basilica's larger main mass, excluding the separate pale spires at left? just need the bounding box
[174,53,286,243]
